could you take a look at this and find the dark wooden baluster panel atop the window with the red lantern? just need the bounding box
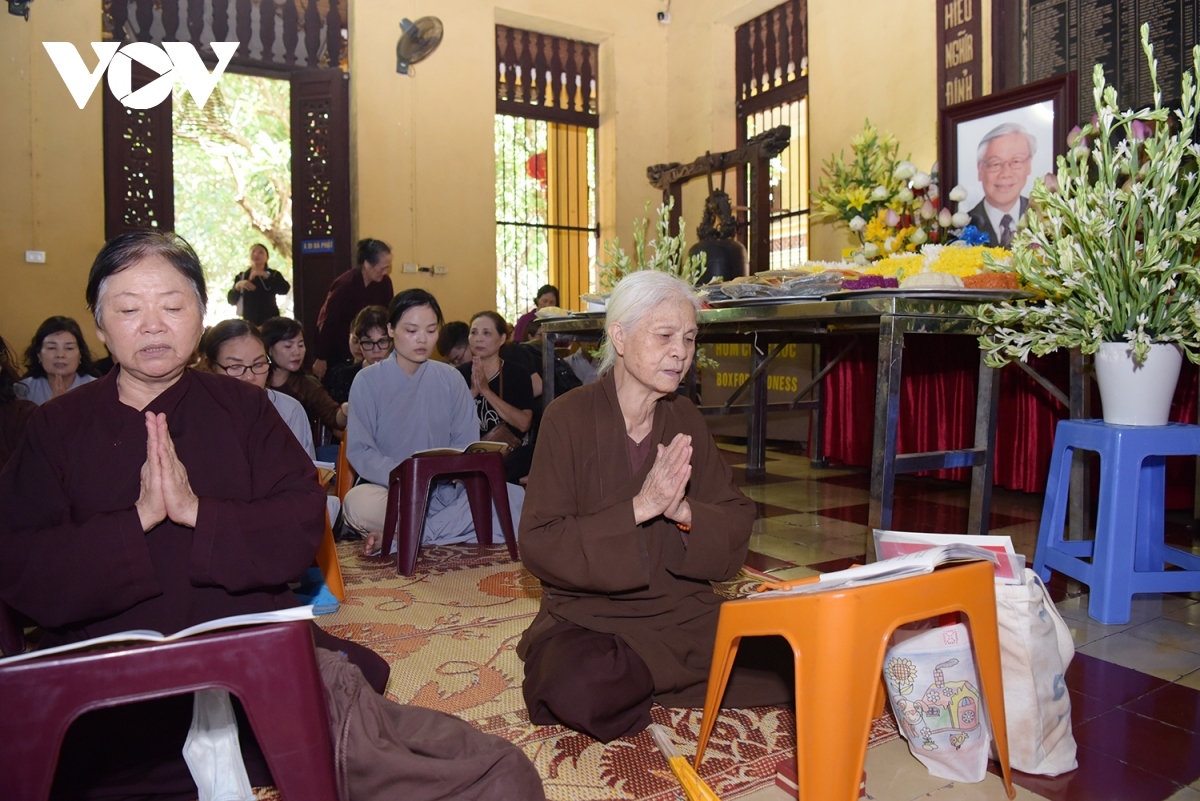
[496,25,600,128]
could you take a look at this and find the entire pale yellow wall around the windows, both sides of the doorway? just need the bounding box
[0,0,937,347]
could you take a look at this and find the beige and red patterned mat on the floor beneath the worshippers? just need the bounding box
[317,543,896,801]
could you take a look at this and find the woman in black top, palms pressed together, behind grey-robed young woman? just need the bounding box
[458,312,534,484]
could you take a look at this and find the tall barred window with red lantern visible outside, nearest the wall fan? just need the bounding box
[496,25,600,321]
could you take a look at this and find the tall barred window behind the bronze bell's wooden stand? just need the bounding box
[736,0,809,270]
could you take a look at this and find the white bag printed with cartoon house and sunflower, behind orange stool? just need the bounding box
[883,624,991,782]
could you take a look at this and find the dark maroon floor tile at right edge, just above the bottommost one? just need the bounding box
[1075,709,1200,784]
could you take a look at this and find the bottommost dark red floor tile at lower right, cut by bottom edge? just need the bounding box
[989,747,1180,801]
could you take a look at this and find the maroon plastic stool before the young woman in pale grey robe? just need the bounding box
[380,453,520,576]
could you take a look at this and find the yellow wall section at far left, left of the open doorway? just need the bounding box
[0,0,104,351]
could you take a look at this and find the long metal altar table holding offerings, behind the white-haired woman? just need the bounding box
[541,291,1000,534]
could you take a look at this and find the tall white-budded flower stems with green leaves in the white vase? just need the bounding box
[976,25,1200,367]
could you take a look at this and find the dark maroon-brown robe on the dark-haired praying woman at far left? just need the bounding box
[0,369,348,799]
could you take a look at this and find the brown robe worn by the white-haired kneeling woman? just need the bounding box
[517,374,787,706]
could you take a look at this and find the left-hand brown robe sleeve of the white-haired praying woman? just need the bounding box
[517,404,652,592]
